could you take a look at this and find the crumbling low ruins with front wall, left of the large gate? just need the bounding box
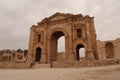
[0,49,27,69]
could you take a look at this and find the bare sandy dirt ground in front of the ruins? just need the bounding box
[0,65,120,80]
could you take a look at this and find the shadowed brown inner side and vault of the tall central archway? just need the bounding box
[50,31,65,61]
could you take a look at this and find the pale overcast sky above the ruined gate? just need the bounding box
[0,0,120,49]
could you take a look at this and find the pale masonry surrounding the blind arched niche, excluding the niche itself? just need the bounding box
[97,38,120,60]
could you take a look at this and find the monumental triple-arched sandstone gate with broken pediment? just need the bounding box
[28,13,98,63]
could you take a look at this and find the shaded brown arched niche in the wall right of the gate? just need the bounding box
[105,42,115,59]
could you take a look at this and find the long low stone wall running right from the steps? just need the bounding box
[51,59,120,68]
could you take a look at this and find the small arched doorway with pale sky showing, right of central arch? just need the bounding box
[76,44,85,60]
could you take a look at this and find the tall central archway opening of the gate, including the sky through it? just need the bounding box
[50,31,65,61]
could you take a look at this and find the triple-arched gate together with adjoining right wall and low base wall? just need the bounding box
[0,13,120,68]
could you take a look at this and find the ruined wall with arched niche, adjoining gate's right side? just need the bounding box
[97,38,120,60]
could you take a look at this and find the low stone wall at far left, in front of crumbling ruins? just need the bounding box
[0,62,30,69]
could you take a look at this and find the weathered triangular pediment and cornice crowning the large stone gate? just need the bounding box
[32,12,94,27]
